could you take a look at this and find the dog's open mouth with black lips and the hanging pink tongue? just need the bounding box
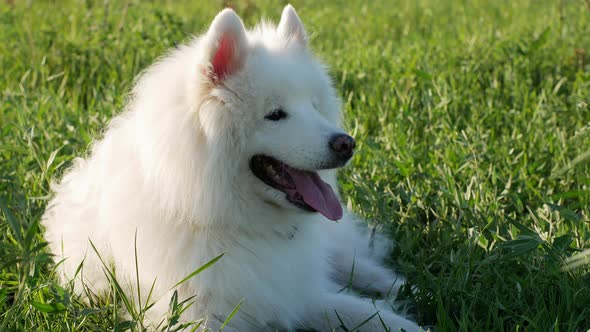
[250,155,342,221]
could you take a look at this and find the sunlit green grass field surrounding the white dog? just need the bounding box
[0,0,590,331]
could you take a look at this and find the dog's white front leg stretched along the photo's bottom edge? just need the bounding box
[304,293,420,332]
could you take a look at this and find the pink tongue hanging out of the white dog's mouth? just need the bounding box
[289,169,342,221]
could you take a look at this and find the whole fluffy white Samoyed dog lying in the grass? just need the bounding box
[42,5,419,332]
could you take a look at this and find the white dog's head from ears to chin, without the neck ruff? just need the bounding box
[195,5,355,220]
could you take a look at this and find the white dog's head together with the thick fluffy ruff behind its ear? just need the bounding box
[135,5,355,220]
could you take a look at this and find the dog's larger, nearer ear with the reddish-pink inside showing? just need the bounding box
[206,8,248,82]
